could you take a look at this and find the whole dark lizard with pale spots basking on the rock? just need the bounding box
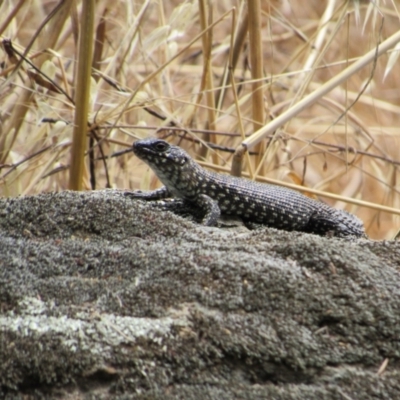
[126,138,365,237]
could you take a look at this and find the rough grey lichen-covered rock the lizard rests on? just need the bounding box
[0,191,400,400]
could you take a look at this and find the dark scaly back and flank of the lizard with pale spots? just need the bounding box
[198,171,364,236]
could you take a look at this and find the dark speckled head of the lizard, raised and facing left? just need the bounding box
[132,138,190,170]
